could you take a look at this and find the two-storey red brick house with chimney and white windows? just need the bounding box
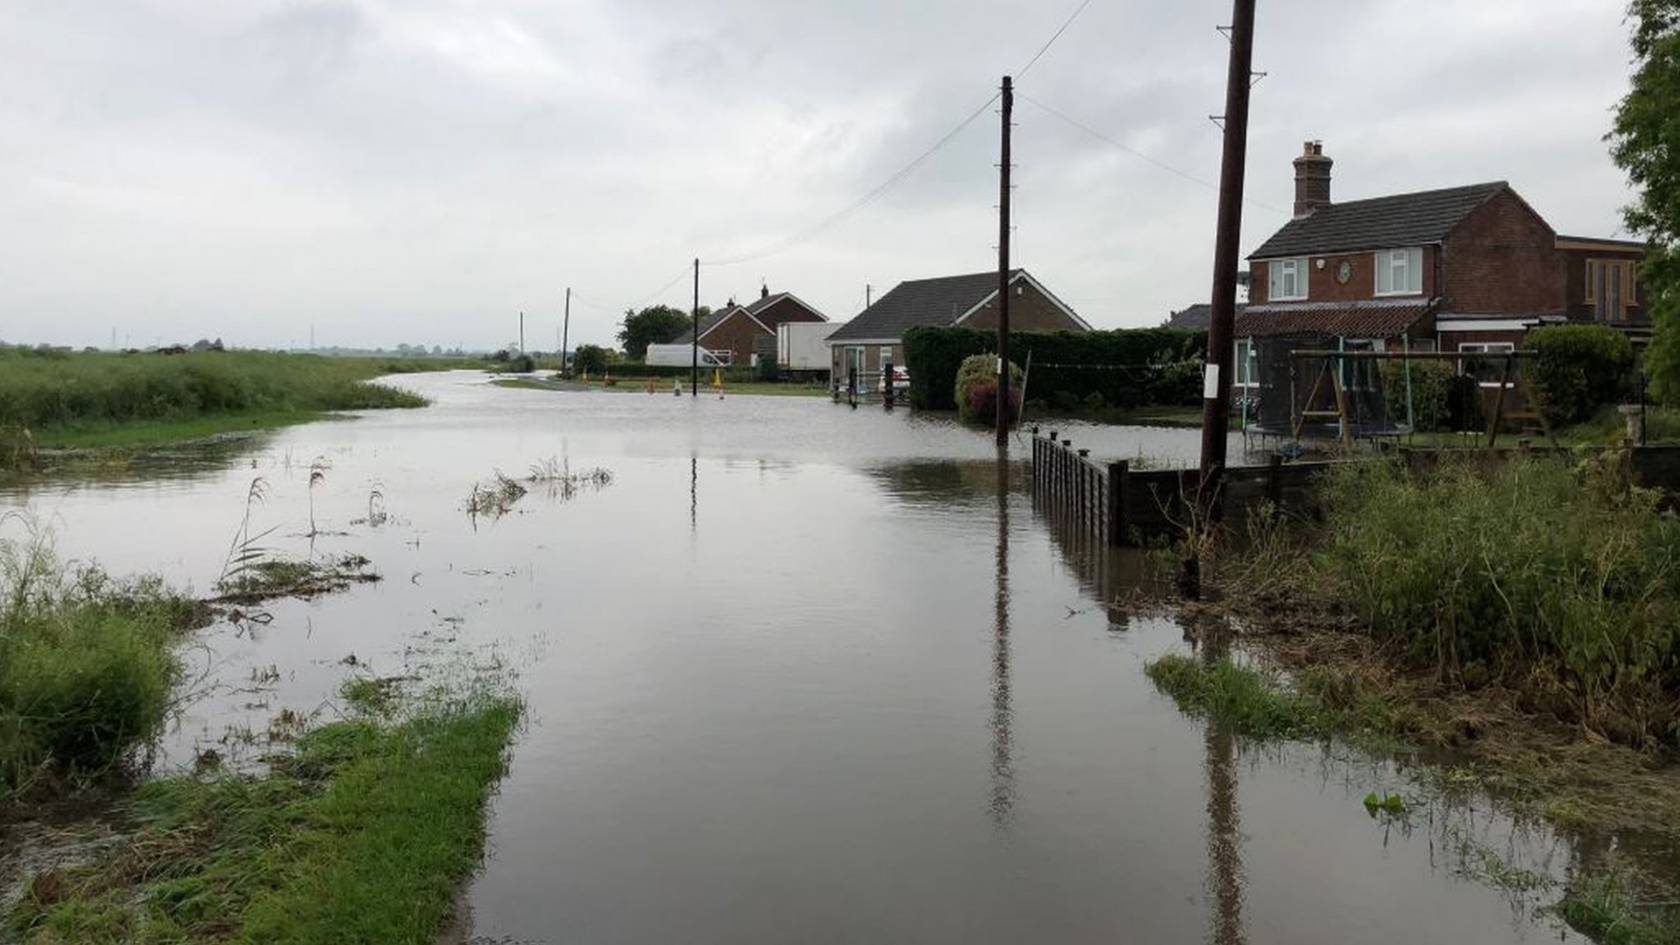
[1233,141,1650,393]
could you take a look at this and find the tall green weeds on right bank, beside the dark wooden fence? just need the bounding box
[1314,454,1680,745]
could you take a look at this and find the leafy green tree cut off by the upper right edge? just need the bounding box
[1608,0,1680,393]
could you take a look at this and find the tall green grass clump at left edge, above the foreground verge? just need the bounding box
[0,541,200,805]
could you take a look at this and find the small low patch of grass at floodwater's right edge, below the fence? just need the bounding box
[1144,654,1410,748]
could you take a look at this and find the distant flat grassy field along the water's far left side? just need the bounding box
[0,348,463,467]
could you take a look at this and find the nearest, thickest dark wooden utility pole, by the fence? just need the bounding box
[1198,0,1255,523]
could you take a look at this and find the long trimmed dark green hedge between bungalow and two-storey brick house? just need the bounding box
[904,328,1208,410]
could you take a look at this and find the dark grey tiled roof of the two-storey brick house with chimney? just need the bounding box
[1248,180,1510,259]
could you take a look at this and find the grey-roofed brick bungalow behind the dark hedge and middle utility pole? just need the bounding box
[828,269,1090,378]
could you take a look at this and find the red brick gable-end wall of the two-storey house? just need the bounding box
[1440,190,1566,314]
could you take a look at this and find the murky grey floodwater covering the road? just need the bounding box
[0,373,1574,945]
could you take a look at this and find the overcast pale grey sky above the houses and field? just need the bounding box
[0,0,1628,346]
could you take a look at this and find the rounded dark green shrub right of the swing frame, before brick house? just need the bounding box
[1522,325,1633,424]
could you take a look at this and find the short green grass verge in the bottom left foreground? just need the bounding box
[7,696,521,945]
